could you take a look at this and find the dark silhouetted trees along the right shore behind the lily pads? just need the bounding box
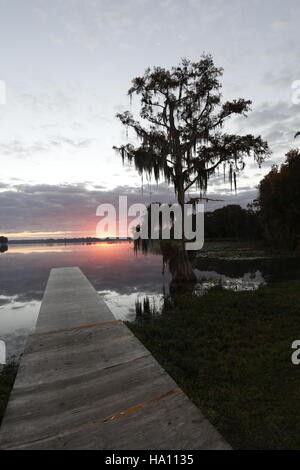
[205,149,300,250]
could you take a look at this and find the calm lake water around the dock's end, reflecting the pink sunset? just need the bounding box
[0,242,167,357]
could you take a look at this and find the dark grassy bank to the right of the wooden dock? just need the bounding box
[128,281,300,449]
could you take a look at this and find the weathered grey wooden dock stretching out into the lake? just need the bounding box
[0,268,230,450]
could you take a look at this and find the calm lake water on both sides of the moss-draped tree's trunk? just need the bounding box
[0,242,300,357]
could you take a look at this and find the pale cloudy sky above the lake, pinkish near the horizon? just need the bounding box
[0,0,300,238]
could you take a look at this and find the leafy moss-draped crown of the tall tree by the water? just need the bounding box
[114,55,269,282]
